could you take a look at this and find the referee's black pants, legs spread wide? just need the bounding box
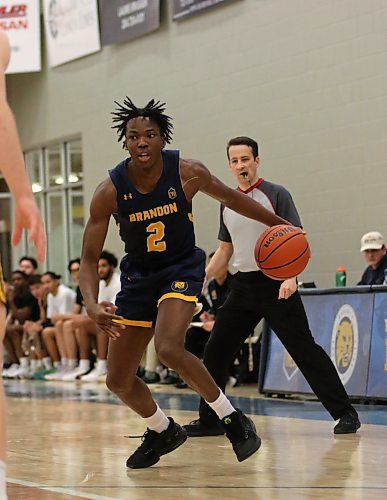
[199,271,351,425]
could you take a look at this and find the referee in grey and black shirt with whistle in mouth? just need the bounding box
[184,137,360,436]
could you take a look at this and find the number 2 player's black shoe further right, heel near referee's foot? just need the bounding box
[222,409,261,462]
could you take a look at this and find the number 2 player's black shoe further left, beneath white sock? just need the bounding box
[126,417,187,469]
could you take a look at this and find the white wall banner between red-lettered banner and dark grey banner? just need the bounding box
[43,0,101,68]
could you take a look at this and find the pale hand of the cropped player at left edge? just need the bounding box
[12,195,47,262]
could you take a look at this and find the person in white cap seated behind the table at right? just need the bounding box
[358,231,387,285]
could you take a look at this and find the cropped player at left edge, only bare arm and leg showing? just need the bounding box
[0,30,46,500]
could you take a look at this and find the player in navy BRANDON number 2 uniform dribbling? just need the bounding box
[80,98,292,468]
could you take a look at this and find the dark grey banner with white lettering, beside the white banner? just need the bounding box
[100,0,160,45]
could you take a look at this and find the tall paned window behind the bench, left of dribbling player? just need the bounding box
[22,139,84,281]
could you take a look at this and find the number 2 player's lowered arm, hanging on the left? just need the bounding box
[79,179,122,338]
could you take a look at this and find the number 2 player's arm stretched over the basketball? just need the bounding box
[181,160,289,226]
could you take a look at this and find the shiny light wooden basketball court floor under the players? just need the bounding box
[5,380,387,500]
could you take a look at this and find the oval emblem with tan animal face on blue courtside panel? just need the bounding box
[331,304,359,384]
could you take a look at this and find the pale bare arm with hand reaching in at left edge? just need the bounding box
[0,31,46,262]
